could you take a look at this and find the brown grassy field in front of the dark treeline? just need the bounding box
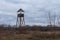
[0,28,60,40]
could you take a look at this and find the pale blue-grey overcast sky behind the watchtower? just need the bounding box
[0,0,60,25]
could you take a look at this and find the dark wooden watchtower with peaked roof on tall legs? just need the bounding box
[16,8,25,27]
